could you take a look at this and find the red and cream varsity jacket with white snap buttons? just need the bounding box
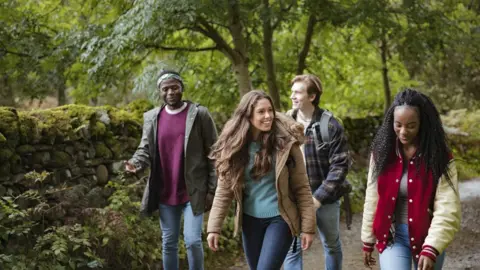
[361,151,461,261]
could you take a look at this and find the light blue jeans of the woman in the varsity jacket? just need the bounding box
[380,224,445,270]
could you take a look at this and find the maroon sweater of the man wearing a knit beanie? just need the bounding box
[158,105,190,205]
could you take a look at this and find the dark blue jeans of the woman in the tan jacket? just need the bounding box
[242,214,293,270]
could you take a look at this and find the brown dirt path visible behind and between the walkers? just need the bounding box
[230,178,480,270]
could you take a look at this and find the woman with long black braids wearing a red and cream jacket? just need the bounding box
[361,89,461,270]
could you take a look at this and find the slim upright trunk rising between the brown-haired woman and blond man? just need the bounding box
[263,0,281,110]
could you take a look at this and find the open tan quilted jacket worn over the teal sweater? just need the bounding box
[207,112,316,236]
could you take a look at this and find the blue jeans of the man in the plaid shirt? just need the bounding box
[283,200,343,270]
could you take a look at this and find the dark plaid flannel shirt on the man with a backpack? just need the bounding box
[292,107,349,204]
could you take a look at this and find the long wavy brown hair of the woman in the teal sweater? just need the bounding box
[210,90,287,190]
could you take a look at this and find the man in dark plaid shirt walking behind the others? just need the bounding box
[284,74,349,270]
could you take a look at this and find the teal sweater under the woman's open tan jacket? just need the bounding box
[243,142,280,218]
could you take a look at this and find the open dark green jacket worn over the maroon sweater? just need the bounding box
[129,101,217,215]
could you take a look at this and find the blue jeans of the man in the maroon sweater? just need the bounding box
[159,202,203,270]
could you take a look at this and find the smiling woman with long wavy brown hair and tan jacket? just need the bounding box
[207,91,315,269]
